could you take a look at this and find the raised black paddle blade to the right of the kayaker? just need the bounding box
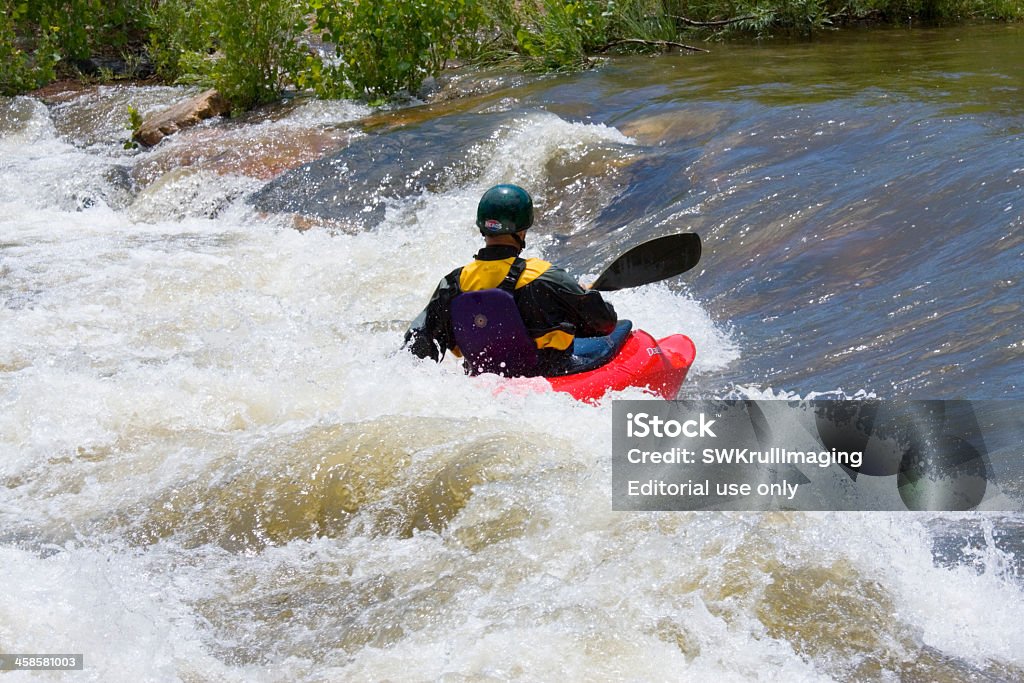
[590,232,700,292]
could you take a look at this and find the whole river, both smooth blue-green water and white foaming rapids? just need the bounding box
[0,26,1024,681]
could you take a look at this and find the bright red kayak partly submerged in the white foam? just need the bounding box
[545,330,696,401]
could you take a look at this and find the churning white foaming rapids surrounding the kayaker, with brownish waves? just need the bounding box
[0,76,1024,682]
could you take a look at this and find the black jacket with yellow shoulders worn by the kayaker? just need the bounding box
[404,246,616,374]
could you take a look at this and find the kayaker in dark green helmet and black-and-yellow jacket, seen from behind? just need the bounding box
[404,184,616,376]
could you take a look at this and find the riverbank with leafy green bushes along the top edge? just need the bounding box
[8,0,1024,107]
